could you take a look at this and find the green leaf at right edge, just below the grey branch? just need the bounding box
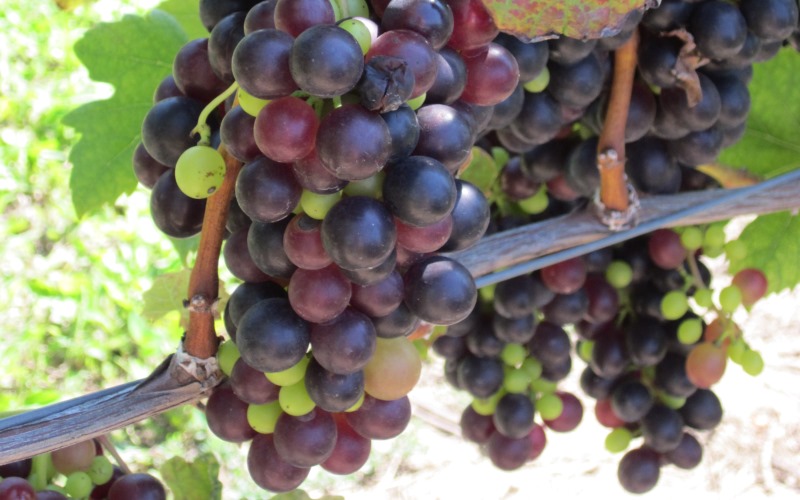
[730,212,800,293]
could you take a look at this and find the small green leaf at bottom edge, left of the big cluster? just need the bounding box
[161,453,222,500]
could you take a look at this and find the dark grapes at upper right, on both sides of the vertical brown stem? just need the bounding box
[472,0,798,207]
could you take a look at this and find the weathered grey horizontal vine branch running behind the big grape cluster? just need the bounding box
[0,180,800,465]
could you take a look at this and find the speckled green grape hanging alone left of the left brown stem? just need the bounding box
[175,146,225,200]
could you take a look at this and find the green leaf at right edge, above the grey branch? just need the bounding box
[720,48,800,177]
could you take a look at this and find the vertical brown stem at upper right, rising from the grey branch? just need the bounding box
[596,31,639,230]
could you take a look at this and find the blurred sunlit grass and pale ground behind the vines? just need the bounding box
[0,0,800,499]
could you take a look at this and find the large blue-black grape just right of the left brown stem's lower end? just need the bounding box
[236,298,309,372]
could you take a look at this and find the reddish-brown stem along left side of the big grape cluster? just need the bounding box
[184,144,242,359]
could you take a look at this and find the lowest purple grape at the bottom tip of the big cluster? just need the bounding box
[247,434,311,493]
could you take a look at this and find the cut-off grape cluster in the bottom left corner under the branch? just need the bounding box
[0,440,167,500]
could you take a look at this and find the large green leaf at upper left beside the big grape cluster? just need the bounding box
[64,11,187,216]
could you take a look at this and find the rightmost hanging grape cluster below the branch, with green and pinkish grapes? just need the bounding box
[576,229,767,493]
